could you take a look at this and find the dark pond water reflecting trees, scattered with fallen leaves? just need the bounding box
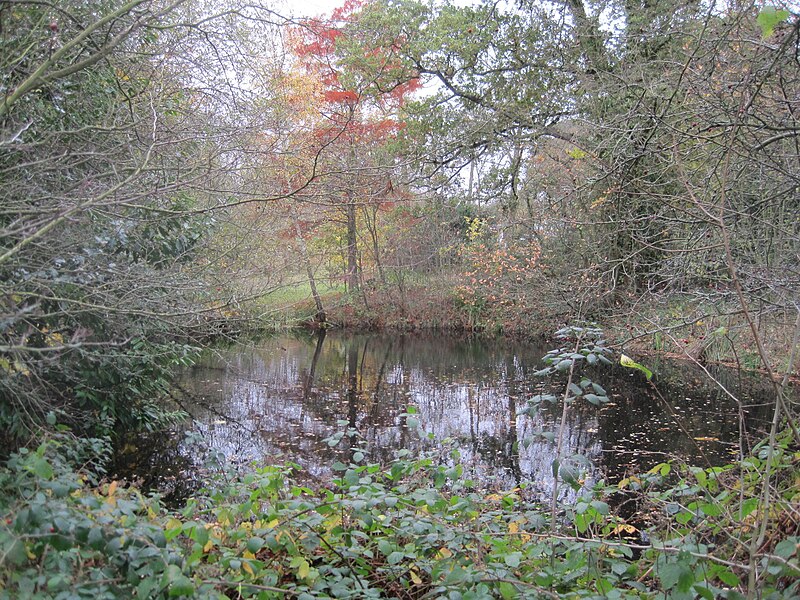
[114,333,771,501]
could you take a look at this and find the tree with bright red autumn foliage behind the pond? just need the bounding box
[288,2,418,300]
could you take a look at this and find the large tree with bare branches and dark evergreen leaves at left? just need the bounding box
[0,0,294,440]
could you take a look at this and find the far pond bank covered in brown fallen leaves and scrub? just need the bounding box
[270,282,800,379]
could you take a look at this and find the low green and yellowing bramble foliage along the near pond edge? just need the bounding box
[0,424,800,598]
